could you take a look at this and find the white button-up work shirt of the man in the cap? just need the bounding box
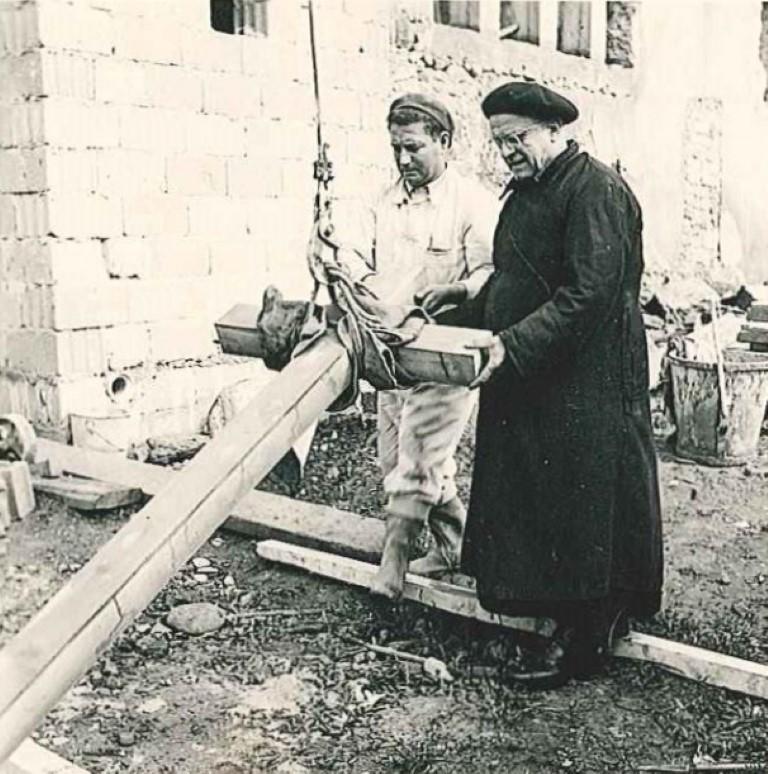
[344,166,499,304]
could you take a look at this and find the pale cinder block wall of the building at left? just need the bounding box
[0,0,388,436]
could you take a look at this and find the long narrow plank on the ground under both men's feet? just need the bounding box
[257,540,768,699]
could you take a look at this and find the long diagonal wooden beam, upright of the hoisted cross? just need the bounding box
[0,336,350,762]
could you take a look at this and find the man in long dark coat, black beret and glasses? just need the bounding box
[447,83,663,685]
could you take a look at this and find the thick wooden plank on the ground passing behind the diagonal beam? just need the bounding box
[38,438,384,561]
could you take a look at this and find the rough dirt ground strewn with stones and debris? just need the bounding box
[0,415,768,774]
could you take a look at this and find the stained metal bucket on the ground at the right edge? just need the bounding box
[669,349,768,466]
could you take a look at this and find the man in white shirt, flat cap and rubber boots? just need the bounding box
[339,94,498,599]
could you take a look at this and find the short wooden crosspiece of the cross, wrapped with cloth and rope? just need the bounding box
[216,304,491,385]
